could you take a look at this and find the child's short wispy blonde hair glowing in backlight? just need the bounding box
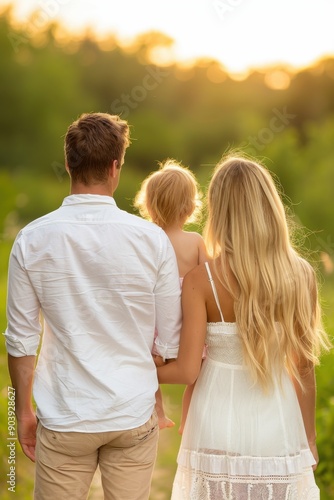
[134,159,202,228]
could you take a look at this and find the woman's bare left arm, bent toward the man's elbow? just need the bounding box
[157,266,207,385]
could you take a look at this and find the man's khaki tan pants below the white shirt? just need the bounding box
[34,413,159,500]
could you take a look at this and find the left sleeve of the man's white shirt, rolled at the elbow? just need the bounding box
[4,235,42,357]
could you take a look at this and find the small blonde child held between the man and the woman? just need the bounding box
[134,159,206,434]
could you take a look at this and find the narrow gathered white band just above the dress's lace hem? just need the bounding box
[178,449,316,477]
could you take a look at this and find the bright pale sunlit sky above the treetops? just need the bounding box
[0,0,334,73]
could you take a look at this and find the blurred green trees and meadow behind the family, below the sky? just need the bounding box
[0,4,334,500]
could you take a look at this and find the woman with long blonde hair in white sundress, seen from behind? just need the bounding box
[158,157,329,500]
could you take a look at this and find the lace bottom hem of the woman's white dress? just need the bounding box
[172,467,320,500]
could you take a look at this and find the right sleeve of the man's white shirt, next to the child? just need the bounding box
[153,233,182,359]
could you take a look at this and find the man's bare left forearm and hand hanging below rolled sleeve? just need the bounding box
[8,354,37,462]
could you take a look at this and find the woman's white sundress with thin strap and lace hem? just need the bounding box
[172,263,320,500]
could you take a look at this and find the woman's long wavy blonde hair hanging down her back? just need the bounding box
[204,156,329,389]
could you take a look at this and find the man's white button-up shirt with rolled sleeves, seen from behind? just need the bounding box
[5,194,181,432]
